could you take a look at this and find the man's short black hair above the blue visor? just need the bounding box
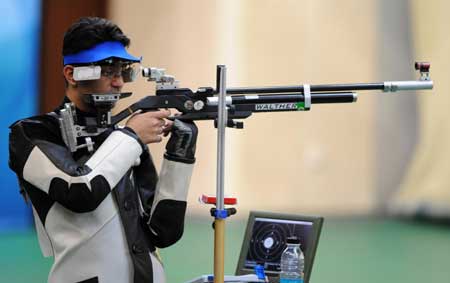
[62,17,130,56]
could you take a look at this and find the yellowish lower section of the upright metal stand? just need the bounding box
[214,219,225,283]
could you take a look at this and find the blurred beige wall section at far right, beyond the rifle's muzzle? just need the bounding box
[389,1,450,221]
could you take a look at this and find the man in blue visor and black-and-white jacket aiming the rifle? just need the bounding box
[10,18,197,283]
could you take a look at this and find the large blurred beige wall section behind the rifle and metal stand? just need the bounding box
[109,0,390,215]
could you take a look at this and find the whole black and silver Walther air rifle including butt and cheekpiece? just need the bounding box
[60,62,433,152]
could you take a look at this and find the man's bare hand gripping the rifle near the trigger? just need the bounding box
[126,110,170,144]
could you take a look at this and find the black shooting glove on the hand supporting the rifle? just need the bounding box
[164,119,198,164]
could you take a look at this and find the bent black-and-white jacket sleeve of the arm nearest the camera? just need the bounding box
[9,119,143,213]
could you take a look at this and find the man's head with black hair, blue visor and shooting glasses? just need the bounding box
[63,17,141,112]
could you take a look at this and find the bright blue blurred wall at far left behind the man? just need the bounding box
[0,0,41,231]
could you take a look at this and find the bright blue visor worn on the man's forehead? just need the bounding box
[64,41,142,65]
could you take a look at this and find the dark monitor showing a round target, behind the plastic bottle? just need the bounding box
[236,211,323,283]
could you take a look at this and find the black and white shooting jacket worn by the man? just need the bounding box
[9,98,193,283]
